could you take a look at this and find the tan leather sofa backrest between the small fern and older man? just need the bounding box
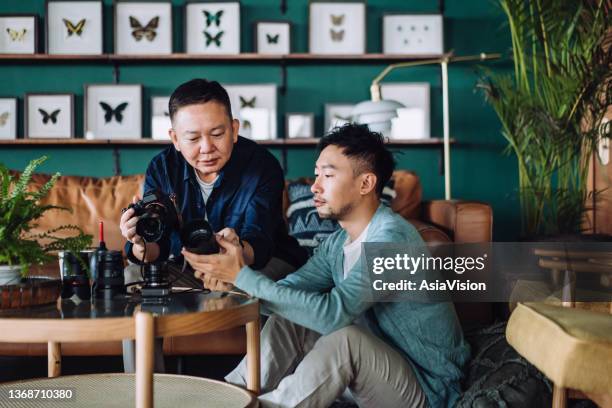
[25,174,144,250]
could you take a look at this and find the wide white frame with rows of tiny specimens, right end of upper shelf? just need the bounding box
[382,14,444,55]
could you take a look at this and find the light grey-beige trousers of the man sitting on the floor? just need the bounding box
[225,315,427,408]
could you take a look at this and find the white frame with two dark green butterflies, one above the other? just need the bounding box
[185,1,240,55]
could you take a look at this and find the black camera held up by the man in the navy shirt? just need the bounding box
[128,190,180,242]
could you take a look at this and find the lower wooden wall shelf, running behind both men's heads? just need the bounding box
[0,137,455,147]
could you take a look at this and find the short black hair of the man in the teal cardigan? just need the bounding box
[318,123,395,197]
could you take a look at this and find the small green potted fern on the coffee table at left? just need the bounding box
[0,156,92,287]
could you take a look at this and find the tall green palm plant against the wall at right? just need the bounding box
[478,0,612,236]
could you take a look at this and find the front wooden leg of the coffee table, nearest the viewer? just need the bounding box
[136,312,154,408]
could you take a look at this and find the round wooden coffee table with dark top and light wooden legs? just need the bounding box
[0,291,260,407]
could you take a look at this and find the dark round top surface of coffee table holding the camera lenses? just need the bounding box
[0,290,257,319]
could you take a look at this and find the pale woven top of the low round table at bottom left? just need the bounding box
[0,374,257,408]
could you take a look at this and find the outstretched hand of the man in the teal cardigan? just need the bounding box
[181,234,245,290]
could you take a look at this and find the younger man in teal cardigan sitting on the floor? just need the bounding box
[183,125,469,407]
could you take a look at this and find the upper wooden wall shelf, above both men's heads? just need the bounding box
[0,53,450,64]
